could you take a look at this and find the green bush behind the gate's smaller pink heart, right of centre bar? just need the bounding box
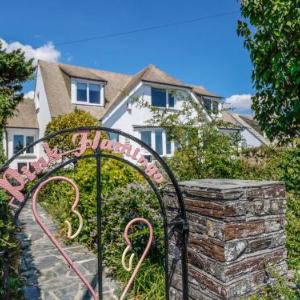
[103,184,165,300]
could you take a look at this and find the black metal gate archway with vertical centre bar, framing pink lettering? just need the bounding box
[0,126,188,299]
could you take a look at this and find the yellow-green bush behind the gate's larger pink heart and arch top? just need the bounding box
[40,158,140,248]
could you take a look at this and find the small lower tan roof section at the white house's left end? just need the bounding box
[6,99,39,128]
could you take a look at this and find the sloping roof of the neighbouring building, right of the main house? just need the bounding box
[222,111,270,145]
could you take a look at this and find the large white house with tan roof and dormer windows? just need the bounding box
[4,61,268,169]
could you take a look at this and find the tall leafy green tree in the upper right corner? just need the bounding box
[237,0,300,141]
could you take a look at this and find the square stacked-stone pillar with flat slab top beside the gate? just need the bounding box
[165,179,287,300]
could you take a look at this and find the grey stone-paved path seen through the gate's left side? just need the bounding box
[18,203,119,300]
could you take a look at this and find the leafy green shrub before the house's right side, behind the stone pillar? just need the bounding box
[137,95,244,180]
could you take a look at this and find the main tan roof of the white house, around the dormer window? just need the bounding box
[39,60,218,119]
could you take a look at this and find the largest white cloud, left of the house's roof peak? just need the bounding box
[0,38,61,64]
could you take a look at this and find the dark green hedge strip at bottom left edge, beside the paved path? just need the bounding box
[0,190,23,299]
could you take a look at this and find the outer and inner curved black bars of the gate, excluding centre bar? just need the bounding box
[0,126,188,299]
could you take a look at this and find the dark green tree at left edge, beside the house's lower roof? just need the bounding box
[0,41,35,131]
